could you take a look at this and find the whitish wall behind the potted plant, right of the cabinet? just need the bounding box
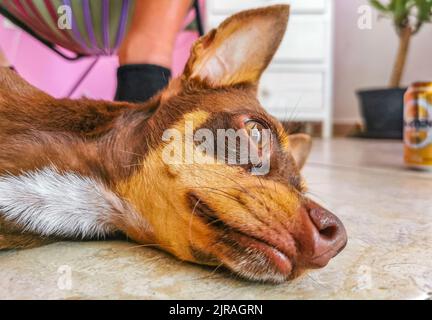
[334,0,432,123]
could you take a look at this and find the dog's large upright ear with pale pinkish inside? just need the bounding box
[184,5,289,86]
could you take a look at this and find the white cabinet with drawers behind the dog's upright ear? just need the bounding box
[206,0,333,137]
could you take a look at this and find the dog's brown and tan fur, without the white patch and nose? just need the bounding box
[0,6,346,282]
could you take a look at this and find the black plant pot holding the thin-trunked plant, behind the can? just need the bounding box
[357,88,406,140]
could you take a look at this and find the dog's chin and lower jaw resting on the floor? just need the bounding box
[219,231,302,284]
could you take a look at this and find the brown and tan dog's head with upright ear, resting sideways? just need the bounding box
[117,5,347,282]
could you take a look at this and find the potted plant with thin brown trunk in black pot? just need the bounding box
[357,0,432,139]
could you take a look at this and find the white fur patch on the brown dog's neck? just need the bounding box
[0,168,124,238]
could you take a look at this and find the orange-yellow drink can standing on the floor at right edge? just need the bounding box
[404,82,432,169]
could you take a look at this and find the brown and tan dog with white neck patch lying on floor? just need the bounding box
[0,5,346,282]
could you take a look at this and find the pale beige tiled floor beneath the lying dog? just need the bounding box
[0,140,432,299]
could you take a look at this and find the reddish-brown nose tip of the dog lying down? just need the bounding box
[307,203,347,267]
